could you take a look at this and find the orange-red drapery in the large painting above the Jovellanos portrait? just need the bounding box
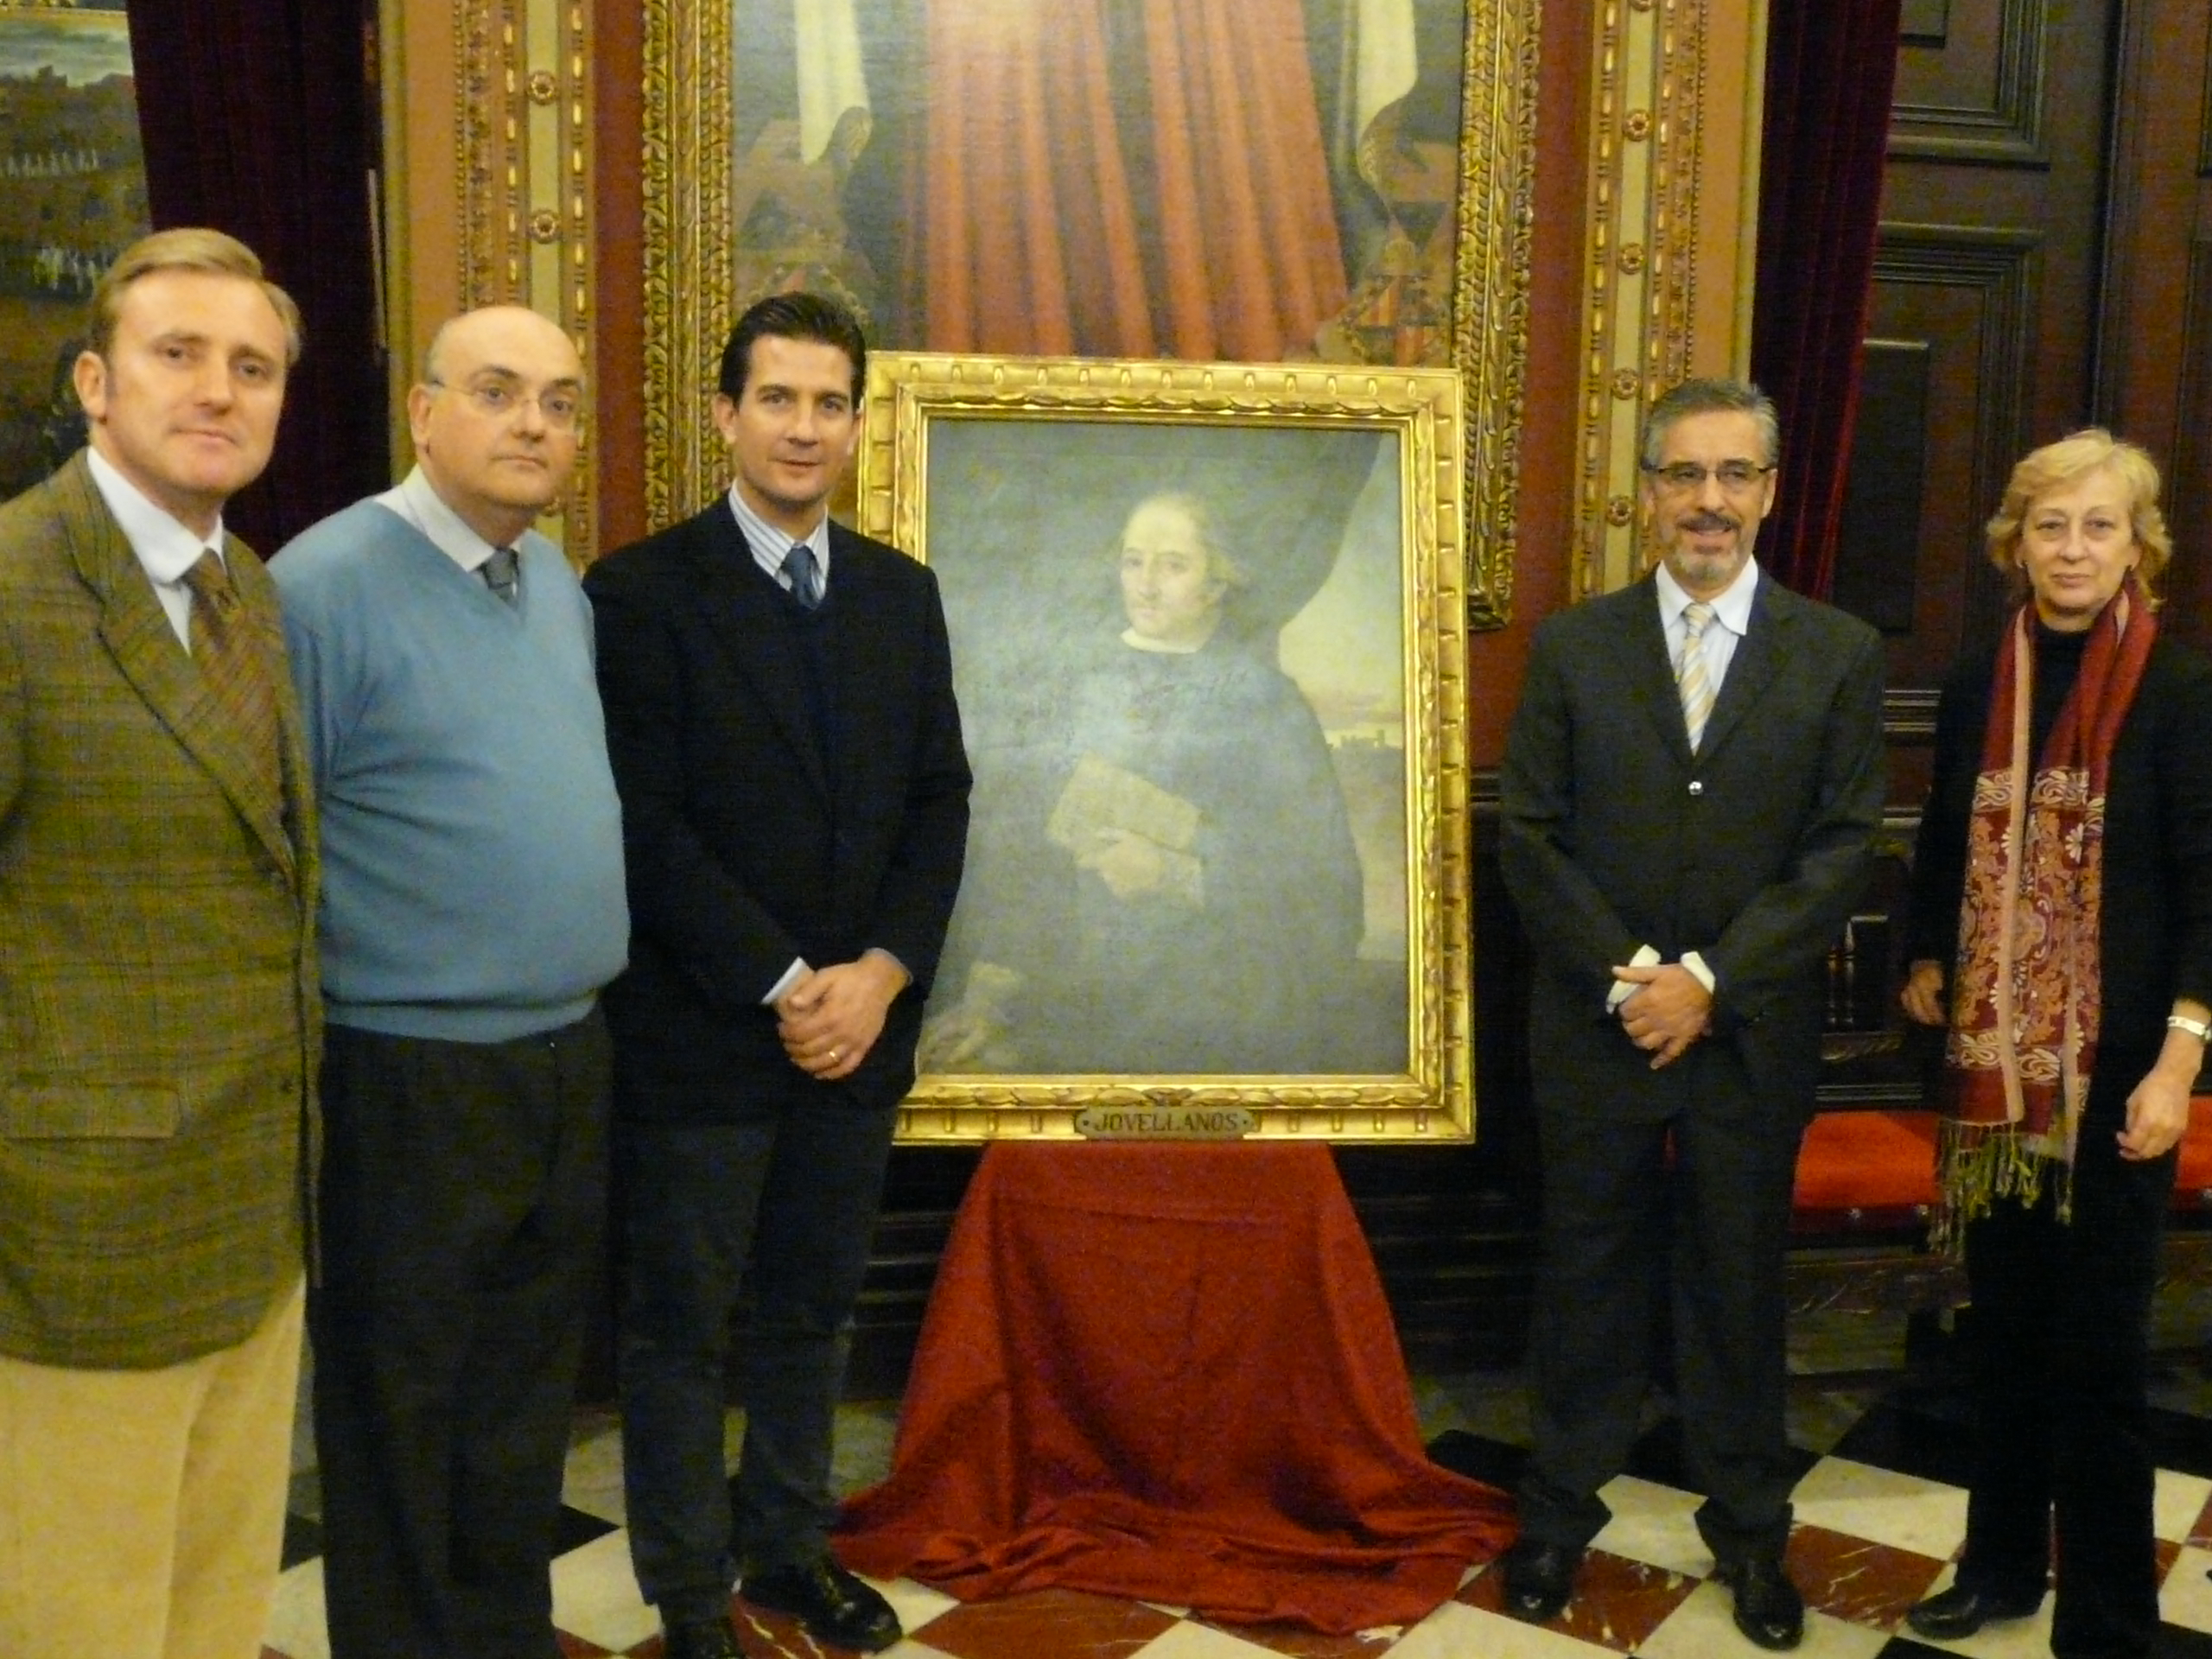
[902,0,1344,360]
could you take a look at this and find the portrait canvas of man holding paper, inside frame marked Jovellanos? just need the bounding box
[923,420,1409,1077]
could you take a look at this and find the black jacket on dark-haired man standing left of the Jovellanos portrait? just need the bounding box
[584,500,969,1122]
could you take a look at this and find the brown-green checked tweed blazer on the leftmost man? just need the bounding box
[0,454,321,1370]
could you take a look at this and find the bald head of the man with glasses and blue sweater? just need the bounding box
[407,305,584,546]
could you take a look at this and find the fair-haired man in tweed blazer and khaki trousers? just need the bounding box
[0,230,321,1659]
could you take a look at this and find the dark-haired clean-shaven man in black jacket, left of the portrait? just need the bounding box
[586,294,969,1659]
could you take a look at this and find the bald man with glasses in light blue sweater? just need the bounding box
[272,305,628,1659]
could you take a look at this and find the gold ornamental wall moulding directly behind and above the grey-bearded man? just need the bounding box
[1573,0,1765,597]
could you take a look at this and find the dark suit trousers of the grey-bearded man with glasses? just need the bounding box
[1520,1038,1802,1561]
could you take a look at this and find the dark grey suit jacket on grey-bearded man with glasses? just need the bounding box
[1500,573,1885,1133]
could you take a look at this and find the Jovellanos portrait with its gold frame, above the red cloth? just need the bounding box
[858,352,1476,1144]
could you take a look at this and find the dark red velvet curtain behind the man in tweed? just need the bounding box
[130,0,390,556]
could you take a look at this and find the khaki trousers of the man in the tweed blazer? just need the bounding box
[0,1283,305,1659]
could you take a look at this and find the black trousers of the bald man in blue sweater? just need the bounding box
[308,1011,608,1659]
